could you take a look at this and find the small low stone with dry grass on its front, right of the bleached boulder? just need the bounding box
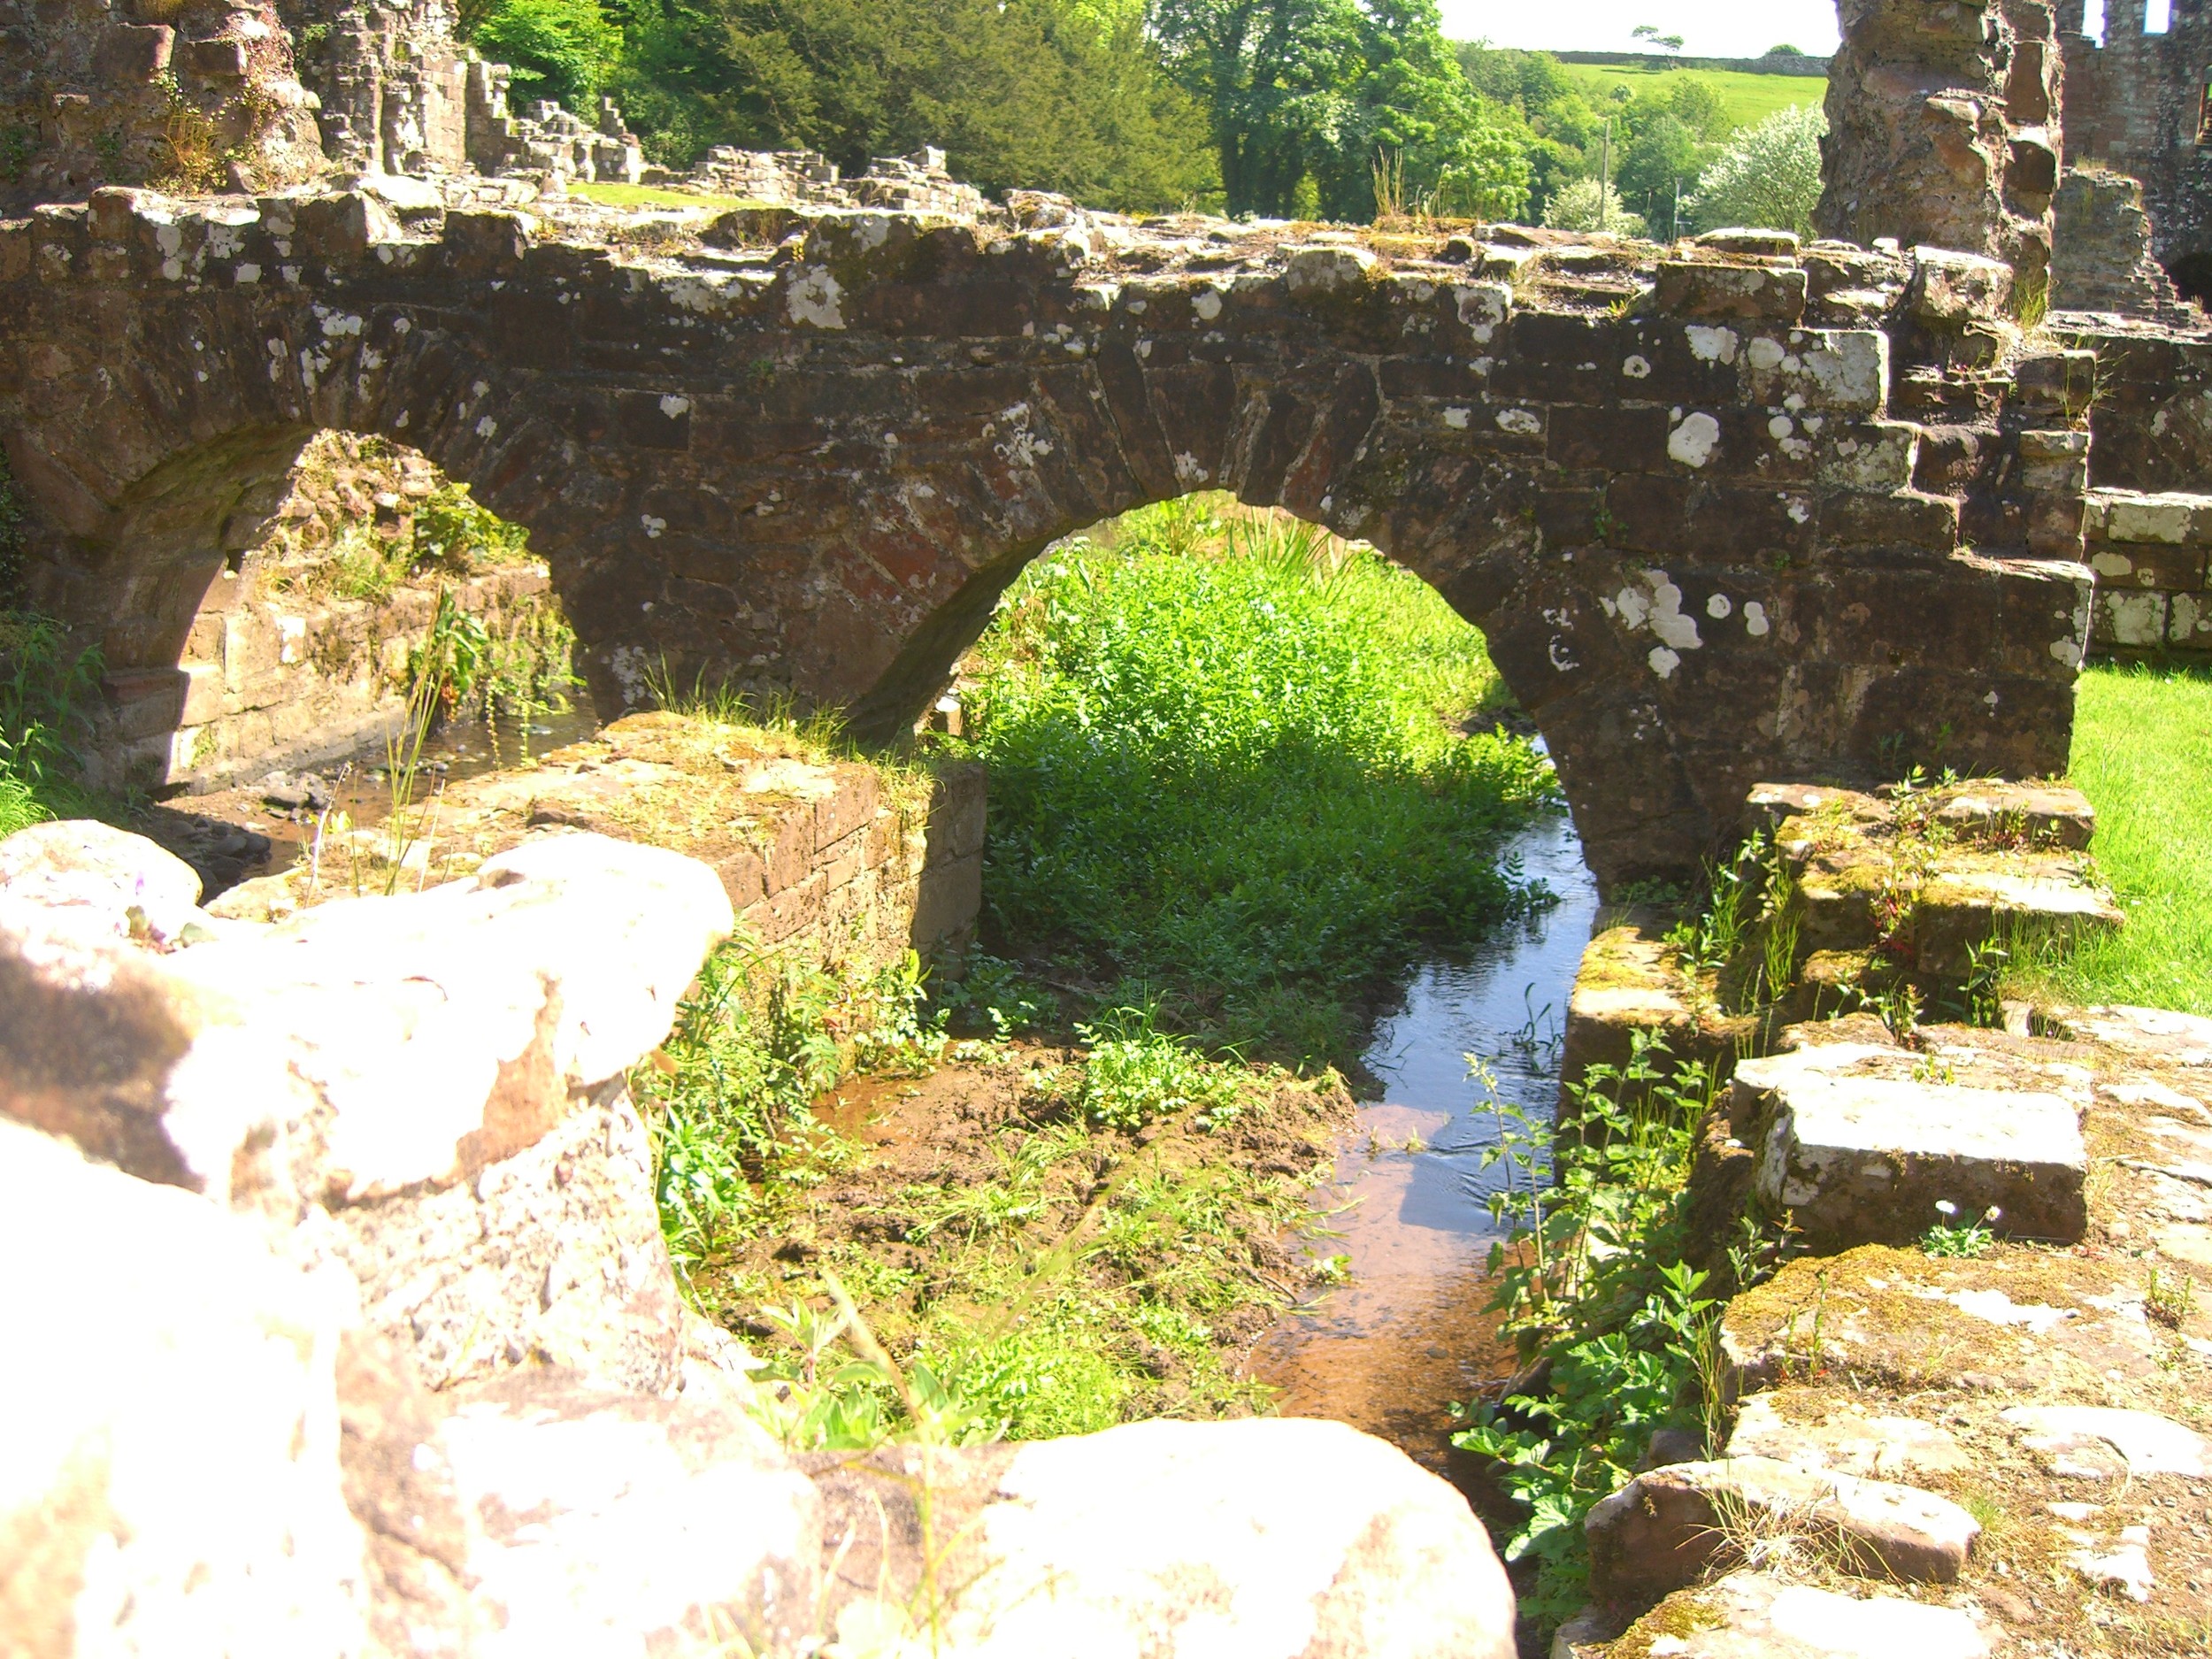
[1584,1458,1982,1604]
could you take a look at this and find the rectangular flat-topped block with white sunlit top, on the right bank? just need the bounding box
[1734,1044,2088,1250]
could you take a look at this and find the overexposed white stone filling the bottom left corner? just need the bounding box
[0,1122,367,1659]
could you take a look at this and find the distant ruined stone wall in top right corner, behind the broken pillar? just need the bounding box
[2060,0,2212,299]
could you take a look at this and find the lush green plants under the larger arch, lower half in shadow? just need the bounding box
[960,500,1553,1064]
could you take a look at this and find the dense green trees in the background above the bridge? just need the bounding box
[460,0,1816,234]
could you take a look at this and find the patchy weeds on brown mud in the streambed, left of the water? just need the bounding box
[633,947,1343,1447]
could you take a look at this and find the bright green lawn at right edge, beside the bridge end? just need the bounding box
[2047,668,2212,1013]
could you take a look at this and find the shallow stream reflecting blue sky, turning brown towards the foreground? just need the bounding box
[1252,812,1597,1469]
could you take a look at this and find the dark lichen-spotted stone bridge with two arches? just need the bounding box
[0,188,2206,885]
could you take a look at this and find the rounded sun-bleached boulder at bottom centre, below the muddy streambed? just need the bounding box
[911,1418,1513,1659]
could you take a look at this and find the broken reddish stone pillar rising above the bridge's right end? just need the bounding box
[1816,0,2062,283]
